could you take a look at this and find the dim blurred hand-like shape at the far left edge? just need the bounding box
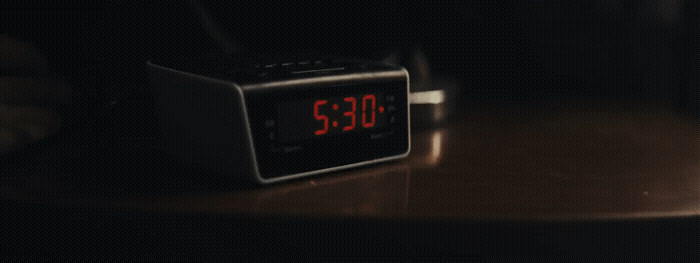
[0,36,70,154]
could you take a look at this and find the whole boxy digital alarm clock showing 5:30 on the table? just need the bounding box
[148,59,411,184]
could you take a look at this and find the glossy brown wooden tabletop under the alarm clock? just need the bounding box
[0,104,700,221]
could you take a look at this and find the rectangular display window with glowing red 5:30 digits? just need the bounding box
[277,92,388,143]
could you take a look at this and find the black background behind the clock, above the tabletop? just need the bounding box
[0,0,700,146]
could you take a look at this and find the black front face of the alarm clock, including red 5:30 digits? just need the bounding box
[246,79,408,179]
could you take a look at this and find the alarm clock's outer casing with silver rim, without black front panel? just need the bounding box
[148,62,411,184]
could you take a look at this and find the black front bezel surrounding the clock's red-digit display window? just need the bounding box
[245,78,410,181]
